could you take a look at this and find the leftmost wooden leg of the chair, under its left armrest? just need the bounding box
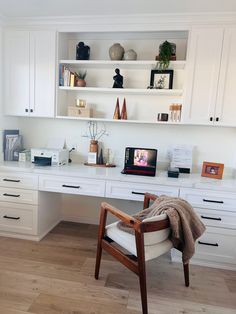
[94,207,107,279]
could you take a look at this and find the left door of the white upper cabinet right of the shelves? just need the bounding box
[183,28,223,124]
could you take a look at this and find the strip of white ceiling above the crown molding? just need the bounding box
[0,0,236,17]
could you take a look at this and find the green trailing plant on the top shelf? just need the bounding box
[156,40,175,70]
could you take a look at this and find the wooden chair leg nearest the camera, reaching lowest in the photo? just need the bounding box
[135,232,148,314]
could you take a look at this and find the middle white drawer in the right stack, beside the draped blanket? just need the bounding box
[195,208,236,230]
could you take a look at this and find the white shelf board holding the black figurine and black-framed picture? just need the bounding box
[59,86,183,96]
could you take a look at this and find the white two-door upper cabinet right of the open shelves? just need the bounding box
[184,28,236,126]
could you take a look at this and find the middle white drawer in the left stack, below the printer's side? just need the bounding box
[0,187,38,205]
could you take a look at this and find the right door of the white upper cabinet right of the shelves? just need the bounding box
[215,28,236,126]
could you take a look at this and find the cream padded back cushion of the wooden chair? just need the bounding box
[142,213,170,246]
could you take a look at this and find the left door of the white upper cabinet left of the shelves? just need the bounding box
[3,31,30,116]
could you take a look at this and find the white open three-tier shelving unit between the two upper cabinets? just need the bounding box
[56,31,188,124]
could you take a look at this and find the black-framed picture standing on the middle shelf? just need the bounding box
[150,70,174,89]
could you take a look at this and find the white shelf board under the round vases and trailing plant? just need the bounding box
[59,60,186,70]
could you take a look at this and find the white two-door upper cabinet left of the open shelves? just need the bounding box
[4,30,56,117]
